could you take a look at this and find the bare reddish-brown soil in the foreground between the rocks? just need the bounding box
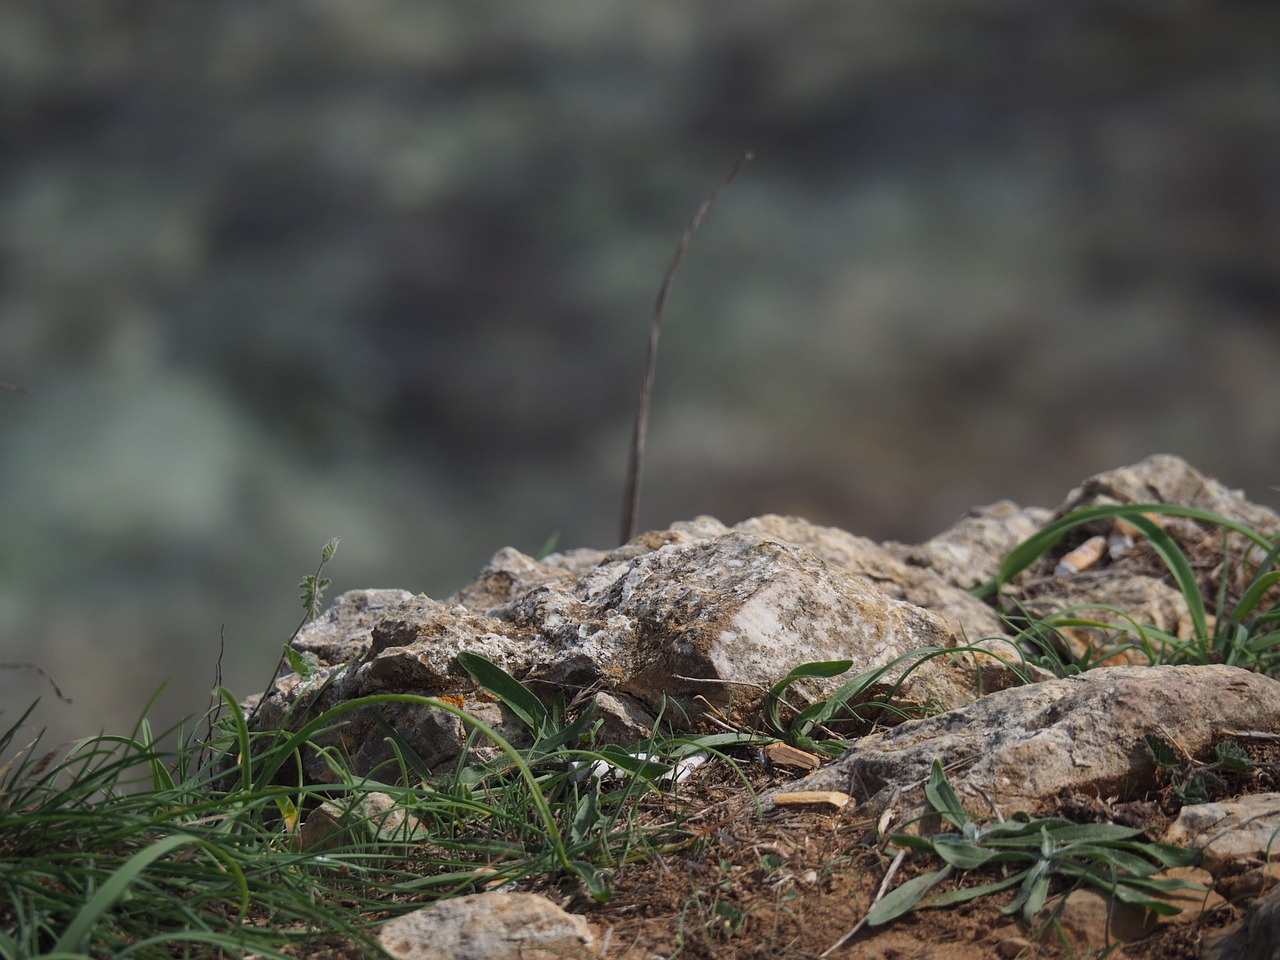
[558,742,1276,960]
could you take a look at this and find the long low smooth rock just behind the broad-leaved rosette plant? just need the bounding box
[765,666,1280,820]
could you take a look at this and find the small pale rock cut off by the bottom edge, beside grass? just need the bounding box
[378,892,595,960]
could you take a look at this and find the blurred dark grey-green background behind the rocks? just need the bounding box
[0,0,1280,752]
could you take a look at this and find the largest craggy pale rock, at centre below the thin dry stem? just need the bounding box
[259,517,1014,780]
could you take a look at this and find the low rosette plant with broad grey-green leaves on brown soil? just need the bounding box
[867,760,1201,927]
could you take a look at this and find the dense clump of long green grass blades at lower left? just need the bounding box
[0,658,732,960]
